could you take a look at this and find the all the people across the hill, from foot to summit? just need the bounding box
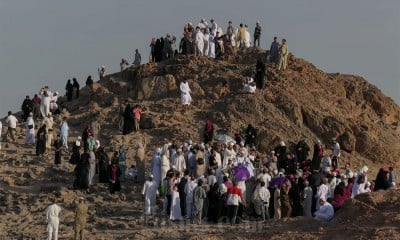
[0,19,396,239]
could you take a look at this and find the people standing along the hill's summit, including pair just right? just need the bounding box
[145,19,289,70]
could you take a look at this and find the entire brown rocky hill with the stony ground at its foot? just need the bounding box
[0,49,400,239]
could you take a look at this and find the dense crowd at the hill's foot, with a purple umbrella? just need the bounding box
[142,129,396,224]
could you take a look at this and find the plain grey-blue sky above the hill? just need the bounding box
[0,0,400,116]
